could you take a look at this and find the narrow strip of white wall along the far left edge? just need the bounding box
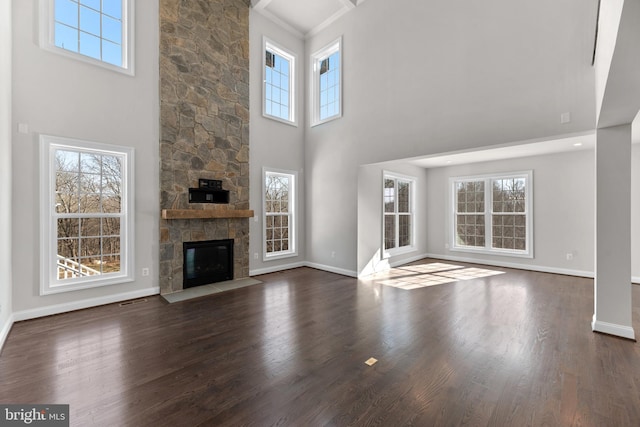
[0,1,12,350]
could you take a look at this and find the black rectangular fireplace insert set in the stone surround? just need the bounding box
[182,239,233,289]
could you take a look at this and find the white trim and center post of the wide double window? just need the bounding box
[448,170,534,258]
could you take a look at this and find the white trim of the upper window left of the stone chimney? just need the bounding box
[39,0,135,76]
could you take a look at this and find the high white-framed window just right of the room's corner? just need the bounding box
[311,38,342,126]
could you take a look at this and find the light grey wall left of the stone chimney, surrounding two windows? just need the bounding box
[12,0,159,320]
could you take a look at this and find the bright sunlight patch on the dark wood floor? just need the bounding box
[371,262,504,290]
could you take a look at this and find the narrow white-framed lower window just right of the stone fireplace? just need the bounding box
[263,169,297,260]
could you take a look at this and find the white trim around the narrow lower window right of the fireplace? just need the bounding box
[262,167,298,262]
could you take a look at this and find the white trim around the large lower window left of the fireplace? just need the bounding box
[40,135,135,295]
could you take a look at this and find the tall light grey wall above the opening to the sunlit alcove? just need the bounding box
[305,0,596,271]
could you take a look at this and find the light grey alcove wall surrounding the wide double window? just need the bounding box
[427,150,595,275]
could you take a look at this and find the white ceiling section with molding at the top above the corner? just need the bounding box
[251,0,364,37]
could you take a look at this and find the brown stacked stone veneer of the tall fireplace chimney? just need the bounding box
[159,0,250,293]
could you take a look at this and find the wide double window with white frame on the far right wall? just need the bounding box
[451,171,533,257]
